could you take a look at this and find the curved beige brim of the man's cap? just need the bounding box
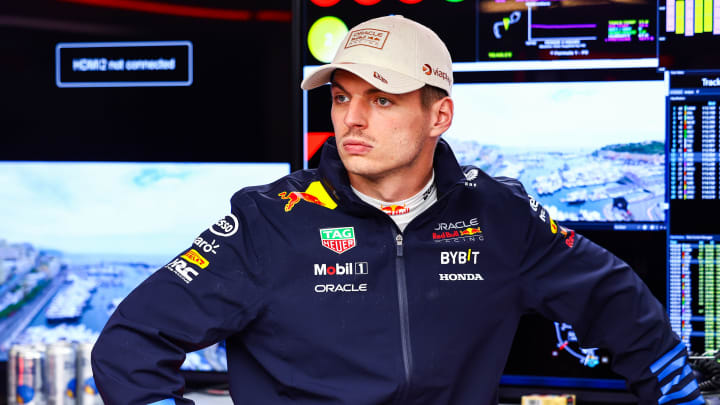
[300,63,425,94]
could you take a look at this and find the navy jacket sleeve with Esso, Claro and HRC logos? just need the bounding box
[92,195,263,405]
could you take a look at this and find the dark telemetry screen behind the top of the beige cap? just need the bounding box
[300,0,657,70]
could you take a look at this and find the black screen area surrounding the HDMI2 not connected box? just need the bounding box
[0,0,300,167]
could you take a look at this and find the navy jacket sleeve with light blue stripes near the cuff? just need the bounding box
[510,182,704,405]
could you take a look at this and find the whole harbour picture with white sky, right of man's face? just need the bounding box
[443,76,667,222]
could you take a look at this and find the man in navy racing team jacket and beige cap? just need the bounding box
[93,16,703,404]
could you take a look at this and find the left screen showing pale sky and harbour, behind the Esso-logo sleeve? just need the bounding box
[0,161,290,371]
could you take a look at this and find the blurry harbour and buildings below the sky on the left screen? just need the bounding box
[0,240,227,370]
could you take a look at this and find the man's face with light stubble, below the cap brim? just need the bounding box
[331,70,436,181]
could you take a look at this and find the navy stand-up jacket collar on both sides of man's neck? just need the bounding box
[318,136,465,210]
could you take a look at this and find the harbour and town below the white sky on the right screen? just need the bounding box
[449,140,665,222]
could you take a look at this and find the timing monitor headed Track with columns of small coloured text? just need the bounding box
[666,71,720,355]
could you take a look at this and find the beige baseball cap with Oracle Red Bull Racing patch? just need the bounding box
[300,15,453,95]
